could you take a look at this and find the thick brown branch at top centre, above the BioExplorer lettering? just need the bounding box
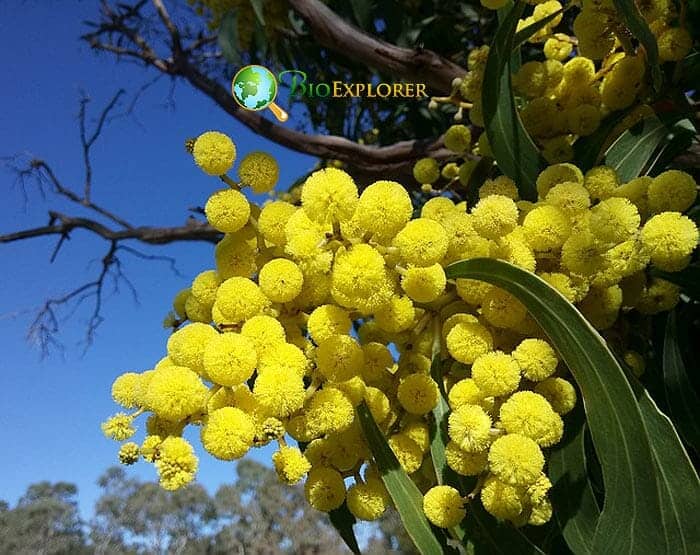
[289,0,467,94]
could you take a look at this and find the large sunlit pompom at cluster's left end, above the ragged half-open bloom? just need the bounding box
[146,366,209,422]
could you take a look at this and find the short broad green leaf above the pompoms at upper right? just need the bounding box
[604,116,669,183]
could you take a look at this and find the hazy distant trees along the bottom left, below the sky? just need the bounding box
[0,460,413,555]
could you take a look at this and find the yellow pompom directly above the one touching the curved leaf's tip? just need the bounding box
[394,218,448,267]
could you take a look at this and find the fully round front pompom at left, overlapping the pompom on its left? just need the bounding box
[202,333,258,387]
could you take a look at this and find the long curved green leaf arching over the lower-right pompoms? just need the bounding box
[446,258,700,554]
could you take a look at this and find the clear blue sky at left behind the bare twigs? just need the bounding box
[0,0,315,515]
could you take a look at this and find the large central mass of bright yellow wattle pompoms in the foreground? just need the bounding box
[103,129,698,527]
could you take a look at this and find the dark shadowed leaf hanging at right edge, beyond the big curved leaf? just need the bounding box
[663,312,700,455]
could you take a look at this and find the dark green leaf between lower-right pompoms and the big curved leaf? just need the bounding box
[549,403,600,553]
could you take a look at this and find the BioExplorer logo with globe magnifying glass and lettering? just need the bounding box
[231,65,428,122]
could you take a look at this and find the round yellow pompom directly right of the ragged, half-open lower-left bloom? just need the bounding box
[201,407,255,461]
